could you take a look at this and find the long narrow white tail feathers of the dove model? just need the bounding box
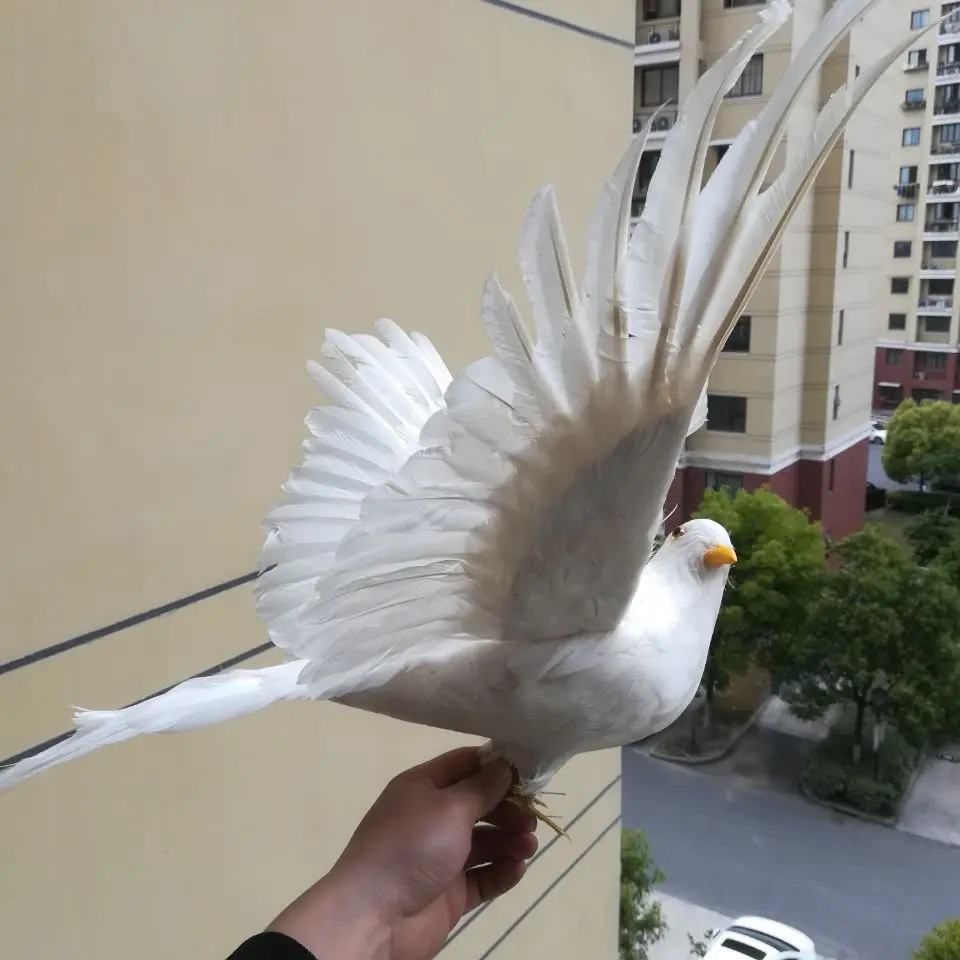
[0,660,310,791]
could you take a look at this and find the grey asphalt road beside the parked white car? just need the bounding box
[623,749,960,960]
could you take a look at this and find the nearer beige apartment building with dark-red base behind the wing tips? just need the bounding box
[633,0,902,537]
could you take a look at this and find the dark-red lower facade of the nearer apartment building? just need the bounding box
[667,439,868,540]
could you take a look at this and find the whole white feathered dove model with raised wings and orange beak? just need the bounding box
[0,0,928,829]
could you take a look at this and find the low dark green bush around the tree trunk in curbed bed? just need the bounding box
[803,710,920,817]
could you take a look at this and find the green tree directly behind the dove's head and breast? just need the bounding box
[696,488,826,724]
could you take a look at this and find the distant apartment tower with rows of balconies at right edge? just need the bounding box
[874,3,960,411]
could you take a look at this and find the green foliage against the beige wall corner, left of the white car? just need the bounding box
[620,830,667,960]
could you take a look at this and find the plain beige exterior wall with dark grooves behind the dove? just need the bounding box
[0,0,634,960]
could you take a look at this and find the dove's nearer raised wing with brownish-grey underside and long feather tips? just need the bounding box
[286,0,936,696]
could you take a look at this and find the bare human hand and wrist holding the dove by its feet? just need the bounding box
[269,748,537,960]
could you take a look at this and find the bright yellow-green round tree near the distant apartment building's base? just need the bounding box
[881,399,960,490]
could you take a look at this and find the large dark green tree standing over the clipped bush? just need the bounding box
[786,526,960,761]
